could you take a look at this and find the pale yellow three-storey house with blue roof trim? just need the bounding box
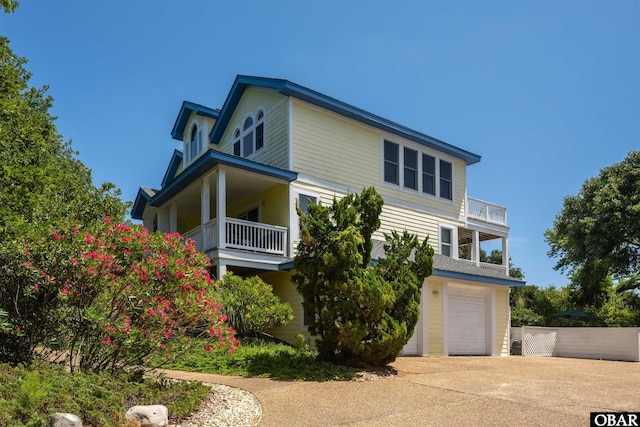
[132,76,523,356]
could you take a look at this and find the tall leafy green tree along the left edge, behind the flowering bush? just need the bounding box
[0,6,126,363]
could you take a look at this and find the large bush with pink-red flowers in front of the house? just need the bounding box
[16,218,239,372]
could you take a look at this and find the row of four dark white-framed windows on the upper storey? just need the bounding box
[382,139,454,200]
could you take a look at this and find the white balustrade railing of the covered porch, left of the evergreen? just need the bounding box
[184,218,288,256]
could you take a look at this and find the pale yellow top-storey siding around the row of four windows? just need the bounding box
[291,100,466,221]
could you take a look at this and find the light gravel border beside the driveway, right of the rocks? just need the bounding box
[170,383,262,427]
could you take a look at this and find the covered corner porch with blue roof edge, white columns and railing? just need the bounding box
[134,150,297,277]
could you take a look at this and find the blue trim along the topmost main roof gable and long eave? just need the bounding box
[209,75,481,165]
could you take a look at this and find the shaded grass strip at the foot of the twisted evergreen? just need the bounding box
[163,341,355,381]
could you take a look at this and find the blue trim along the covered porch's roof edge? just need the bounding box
[149,149,298,206]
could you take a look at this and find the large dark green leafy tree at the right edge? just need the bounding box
[545,151,640,306]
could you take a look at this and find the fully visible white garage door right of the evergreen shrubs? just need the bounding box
[447,286,487,355]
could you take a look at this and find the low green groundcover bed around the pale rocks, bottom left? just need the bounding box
[0,363,209,427]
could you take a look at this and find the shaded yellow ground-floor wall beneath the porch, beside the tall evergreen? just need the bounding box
[260,271,302,343]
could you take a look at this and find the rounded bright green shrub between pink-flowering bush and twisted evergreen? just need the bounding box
[216,273,293,336]
